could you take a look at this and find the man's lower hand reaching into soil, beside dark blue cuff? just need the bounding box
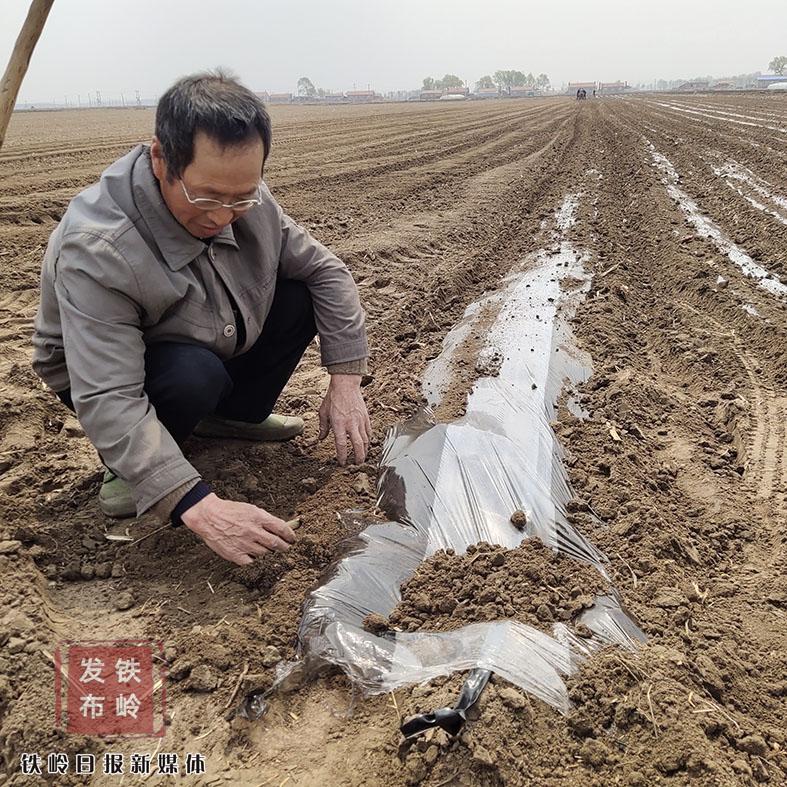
[181,493,295,566]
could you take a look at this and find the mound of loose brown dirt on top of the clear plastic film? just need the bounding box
[389,538,606,636]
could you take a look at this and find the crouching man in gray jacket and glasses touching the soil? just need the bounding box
[33,72,371,565]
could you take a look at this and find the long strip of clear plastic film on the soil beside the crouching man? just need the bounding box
[248,197,644,712]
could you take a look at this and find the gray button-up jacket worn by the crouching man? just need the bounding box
[33,145,368,513]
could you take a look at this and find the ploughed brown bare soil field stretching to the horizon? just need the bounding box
[0,95,787,787]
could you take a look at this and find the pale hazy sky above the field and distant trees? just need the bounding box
[0,0,787,102]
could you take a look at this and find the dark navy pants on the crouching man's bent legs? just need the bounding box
[58,279,317,442]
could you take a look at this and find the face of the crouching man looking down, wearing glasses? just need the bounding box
[150,132,264,239]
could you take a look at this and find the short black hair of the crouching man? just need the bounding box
[156,69,271,178]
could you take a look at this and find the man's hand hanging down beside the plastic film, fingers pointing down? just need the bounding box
[319,374,372,465]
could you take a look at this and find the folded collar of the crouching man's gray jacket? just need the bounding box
[131,145,238,271]
